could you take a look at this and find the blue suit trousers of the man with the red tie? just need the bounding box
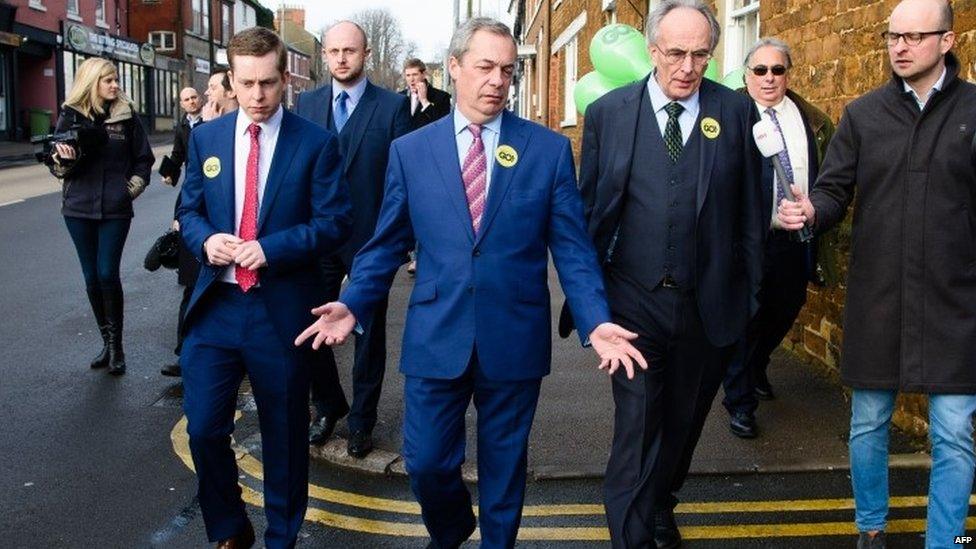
[180,283,309,548]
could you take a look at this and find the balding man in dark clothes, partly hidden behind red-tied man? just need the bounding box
[159,87,203,377]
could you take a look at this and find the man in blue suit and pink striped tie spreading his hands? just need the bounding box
[296,18,646,548]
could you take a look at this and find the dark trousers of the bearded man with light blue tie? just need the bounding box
[311,256,388,432]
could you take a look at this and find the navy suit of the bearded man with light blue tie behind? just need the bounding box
[295,82,410,432]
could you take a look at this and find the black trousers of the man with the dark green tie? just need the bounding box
[604,271,731,549]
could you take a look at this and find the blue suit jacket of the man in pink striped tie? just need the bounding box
[340,111,610,380]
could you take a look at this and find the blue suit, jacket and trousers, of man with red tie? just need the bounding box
[177,111,351,548]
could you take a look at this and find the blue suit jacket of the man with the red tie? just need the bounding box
[177,111,351,346]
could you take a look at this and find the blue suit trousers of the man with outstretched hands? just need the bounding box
[403,356,541,549]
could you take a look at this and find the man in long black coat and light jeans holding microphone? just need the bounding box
[778,0,976,548]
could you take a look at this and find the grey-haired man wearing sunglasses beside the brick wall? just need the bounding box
[722,38,834,438]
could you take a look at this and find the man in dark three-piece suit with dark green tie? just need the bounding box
[560,0,763,548]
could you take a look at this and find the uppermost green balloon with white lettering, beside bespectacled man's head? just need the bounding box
[590,24,653,83]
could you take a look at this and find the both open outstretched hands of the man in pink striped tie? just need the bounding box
[295,301,647,379]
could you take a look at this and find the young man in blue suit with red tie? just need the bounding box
[177,27,352,548]
